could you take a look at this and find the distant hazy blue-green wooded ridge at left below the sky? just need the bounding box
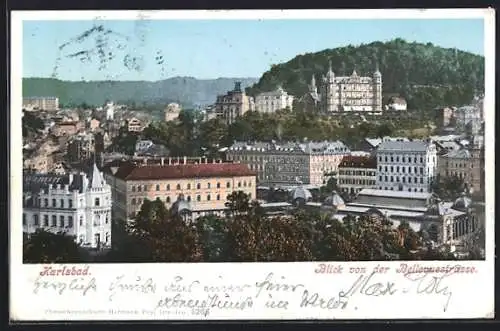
[23,77,257,107]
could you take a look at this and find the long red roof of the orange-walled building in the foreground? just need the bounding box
[111,163,256,180]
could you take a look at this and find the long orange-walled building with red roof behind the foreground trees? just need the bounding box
[105,161,256,220]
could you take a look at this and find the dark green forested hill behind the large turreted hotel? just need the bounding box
[247,39,484,109]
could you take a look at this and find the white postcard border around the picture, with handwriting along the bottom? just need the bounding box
[9,9,495,321]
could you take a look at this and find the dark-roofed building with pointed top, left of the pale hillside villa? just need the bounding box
[215,82,255,124]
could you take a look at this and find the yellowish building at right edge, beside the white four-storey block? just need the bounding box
[438,146,485,195]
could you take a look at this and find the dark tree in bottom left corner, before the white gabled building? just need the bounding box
[23,229,84,263]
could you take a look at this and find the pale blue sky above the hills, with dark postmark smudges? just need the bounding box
[23,18,484,81]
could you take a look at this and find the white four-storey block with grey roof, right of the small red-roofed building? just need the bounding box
[376,140,438,192]
